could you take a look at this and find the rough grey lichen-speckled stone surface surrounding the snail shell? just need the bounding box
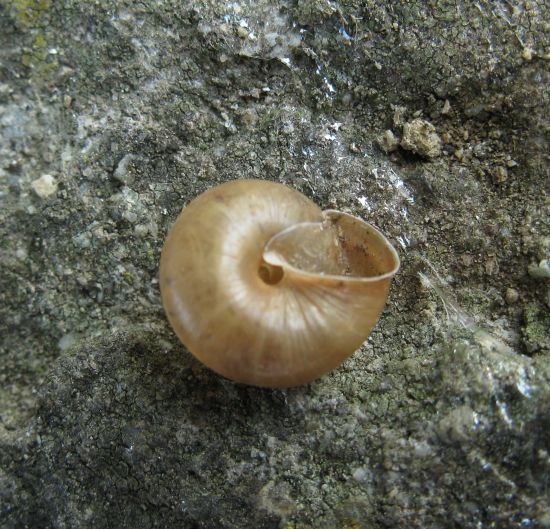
[0,0,550,529]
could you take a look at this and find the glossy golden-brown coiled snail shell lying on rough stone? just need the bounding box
[160,180,399,388]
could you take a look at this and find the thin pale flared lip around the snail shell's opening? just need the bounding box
[264,209,401,283]
